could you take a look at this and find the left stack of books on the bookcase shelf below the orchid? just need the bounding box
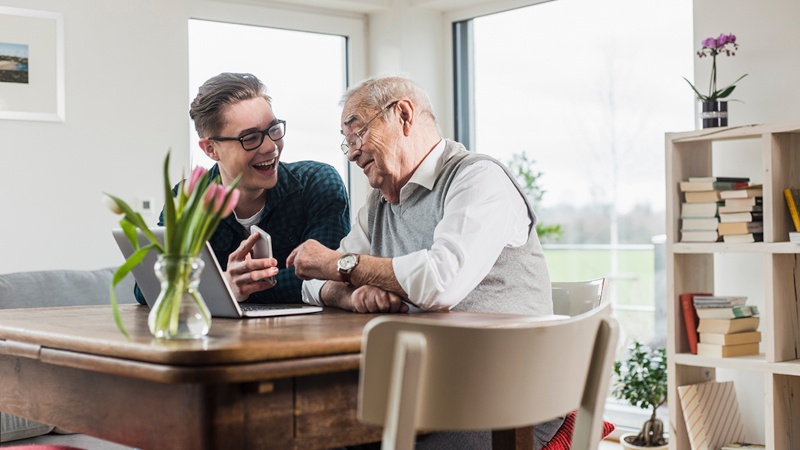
[679,177,750,242]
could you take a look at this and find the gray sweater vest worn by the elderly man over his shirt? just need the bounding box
[368,140,553,315]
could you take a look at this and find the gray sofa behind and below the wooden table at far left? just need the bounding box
[0,268,136,450]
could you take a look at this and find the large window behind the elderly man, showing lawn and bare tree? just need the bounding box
[453,0,694,427]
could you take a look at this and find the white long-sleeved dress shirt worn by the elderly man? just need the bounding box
[303,139,531,310]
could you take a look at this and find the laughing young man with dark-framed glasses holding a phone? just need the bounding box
[137,73,350,303]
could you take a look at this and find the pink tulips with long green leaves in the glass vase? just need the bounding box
[104,152,240,337]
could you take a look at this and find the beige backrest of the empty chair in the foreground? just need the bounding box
[358,304,618,449]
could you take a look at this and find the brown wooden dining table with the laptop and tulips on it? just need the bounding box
[0,305,533,450]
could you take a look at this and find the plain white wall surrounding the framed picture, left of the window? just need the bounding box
[0,0,188,273]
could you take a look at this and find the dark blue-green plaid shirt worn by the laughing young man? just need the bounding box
[135,161,350,303]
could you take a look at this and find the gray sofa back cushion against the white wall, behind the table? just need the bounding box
[0,267,136,308]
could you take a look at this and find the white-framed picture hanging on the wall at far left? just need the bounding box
[0,6,65,122]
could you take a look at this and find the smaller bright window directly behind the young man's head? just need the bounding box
[187,20,348,185]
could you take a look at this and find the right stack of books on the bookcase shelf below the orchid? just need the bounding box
[718,185,764,243]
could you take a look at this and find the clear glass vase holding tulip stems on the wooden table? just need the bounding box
[147,254,211,339]
